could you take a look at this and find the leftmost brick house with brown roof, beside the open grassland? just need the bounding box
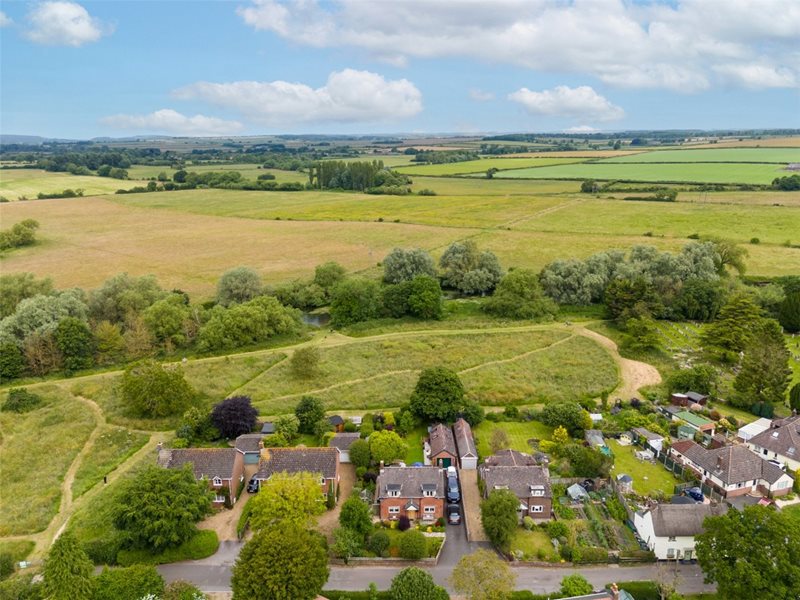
[158,447,244,508]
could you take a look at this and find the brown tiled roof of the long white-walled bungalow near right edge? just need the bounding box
[672,440,784,485]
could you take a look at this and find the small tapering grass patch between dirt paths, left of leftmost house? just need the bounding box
[72,426,150,498]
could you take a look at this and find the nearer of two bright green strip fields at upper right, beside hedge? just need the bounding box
[495,161,791,185]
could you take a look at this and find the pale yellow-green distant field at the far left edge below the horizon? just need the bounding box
[0,169,147,200]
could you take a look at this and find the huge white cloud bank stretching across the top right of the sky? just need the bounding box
[237,0,800,92]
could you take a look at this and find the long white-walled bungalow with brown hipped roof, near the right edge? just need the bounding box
[669,440,794,498]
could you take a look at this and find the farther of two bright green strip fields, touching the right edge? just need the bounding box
[602,148,800,164]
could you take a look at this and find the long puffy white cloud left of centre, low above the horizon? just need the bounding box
[173,69,422,125]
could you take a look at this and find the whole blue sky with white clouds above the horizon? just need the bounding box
[0,0,800,139]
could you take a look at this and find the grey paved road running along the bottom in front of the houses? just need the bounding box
[158,536,714,594]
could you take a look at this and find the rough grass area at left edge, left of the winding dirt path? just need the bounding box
[0,385,96,536]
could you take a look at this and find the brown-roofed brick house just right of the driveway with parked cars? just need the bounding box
[478,452,553,521]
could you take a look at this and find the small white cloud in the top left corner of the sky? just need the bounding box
[25,1,113,47]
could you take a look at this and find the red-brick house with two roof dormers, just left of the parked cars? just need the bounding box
[375,467,445,521]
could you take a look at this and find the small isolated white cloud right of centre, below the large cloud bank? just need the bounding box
[508,85,625,121]
